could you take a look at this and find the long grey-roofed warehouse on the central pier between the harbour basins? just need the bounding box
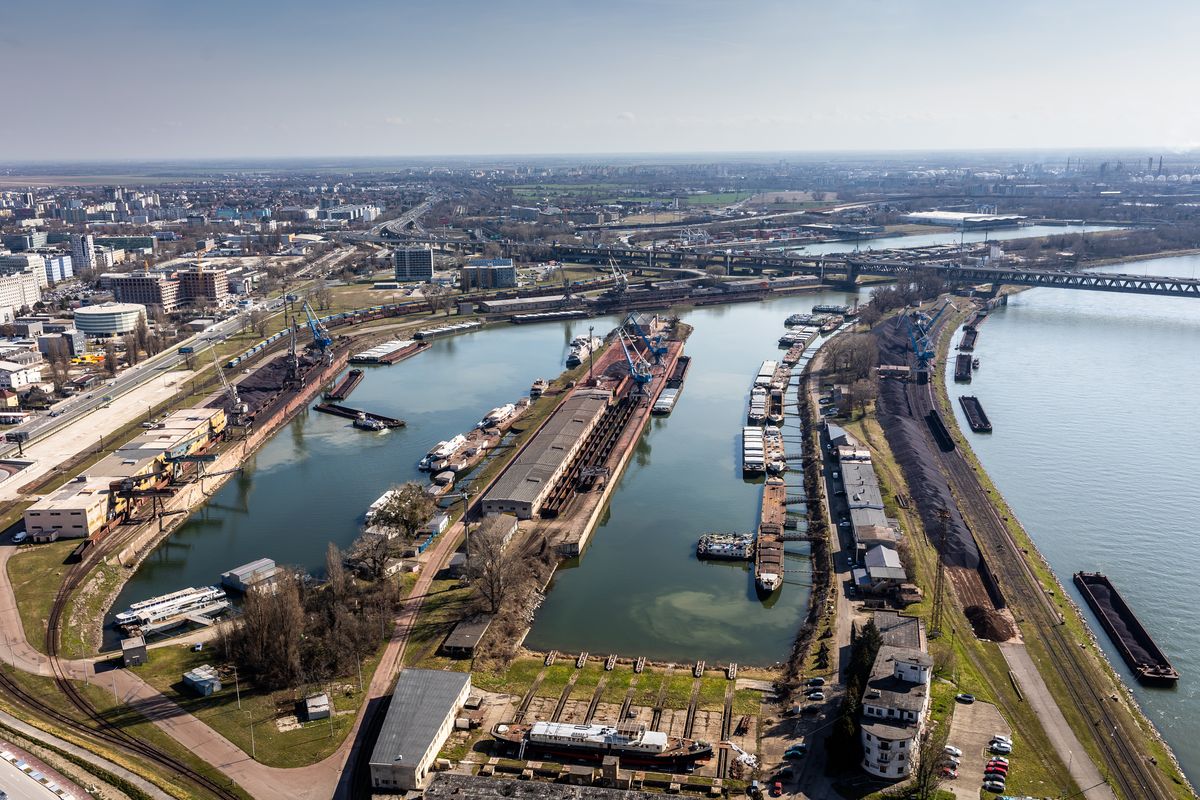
[482,389,612,519]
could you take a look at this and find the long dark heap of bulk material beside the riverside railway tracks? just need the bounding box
[875,317,979,570]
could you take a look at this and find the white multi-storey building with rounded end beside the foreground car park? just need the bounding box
[862,644,934,781]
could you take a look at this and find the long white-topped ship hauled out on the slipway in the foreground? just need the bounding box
[492,722,713,770]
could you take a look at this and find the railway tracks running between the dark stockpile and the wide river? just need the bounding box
[908,323,1171,800]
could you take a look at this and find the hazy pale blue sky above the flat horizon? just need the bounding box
[0,0,1200,162]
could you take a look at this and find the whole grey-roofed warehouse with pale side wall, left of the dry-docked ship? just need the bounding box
[371,669,470,792]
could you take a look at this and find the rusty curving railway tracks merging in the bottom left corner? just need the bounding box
[0,527,242,800]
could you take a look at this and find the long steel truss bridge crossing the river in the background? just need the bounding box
[544,245,1200,297]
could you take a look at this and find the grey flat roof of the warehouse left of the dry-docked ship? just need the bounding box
[371,669,470,769]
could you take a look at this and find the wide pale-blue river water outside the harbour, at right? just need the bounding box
[947,255,1200,782]
